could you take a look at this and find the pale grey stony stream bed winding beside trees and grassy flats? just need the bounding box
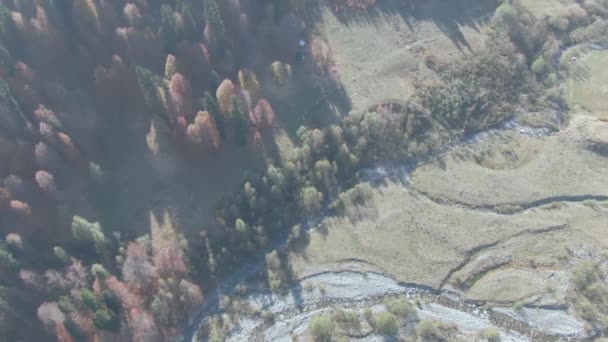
[178,113,587,342]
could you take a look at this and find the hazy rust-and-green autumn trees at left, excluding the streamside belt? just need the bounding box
[0,0,314,341]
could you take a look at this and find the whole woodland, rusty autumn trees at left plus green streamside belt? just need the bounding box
[0,0,605,342]
